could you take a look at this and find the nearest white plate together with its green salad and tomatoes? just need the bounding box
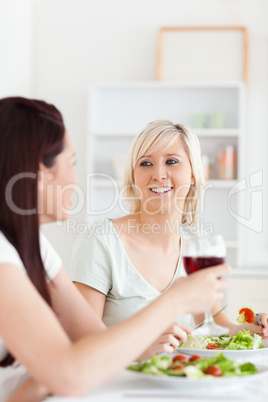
[128,352,268,393]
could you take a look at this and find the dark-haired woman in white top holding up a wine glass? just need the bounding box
[0,97,229,401]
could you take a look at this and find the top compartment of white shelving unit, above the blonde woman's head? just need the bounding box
[88,81,243,133]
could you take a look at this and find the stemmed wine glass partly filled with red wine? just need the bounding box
[182,235,229,336]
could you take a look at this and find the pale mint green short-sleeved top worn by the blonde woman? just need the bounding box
[70,219,191,326]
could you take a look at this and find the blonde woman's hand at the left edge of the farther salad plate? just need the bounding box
[137,322,193,360]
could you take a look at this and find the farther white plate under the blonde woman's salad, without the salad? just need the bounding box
[176,348,268,360]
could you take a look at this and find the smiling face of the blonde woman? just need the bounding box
[134,138,195,214]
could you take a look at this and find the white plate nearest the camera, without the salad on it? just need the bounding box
[128,364,268,391]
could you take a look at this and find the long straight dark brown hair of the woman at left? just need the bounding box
[0,97,65,366]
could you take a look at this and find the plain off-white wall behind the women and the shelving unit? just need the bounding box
[0,0,268,265]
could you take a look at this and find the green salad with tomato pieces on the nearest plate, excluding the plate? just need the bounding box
[128,352,258,378]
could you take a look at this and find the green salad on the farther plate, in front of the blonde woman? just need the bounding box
[179,330,263,350]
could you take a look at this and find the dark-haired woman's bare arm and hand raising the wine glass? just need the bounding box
[0,264,229,396]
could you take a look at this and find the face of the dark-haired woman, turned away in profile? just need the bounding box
[39,133,77,223]
